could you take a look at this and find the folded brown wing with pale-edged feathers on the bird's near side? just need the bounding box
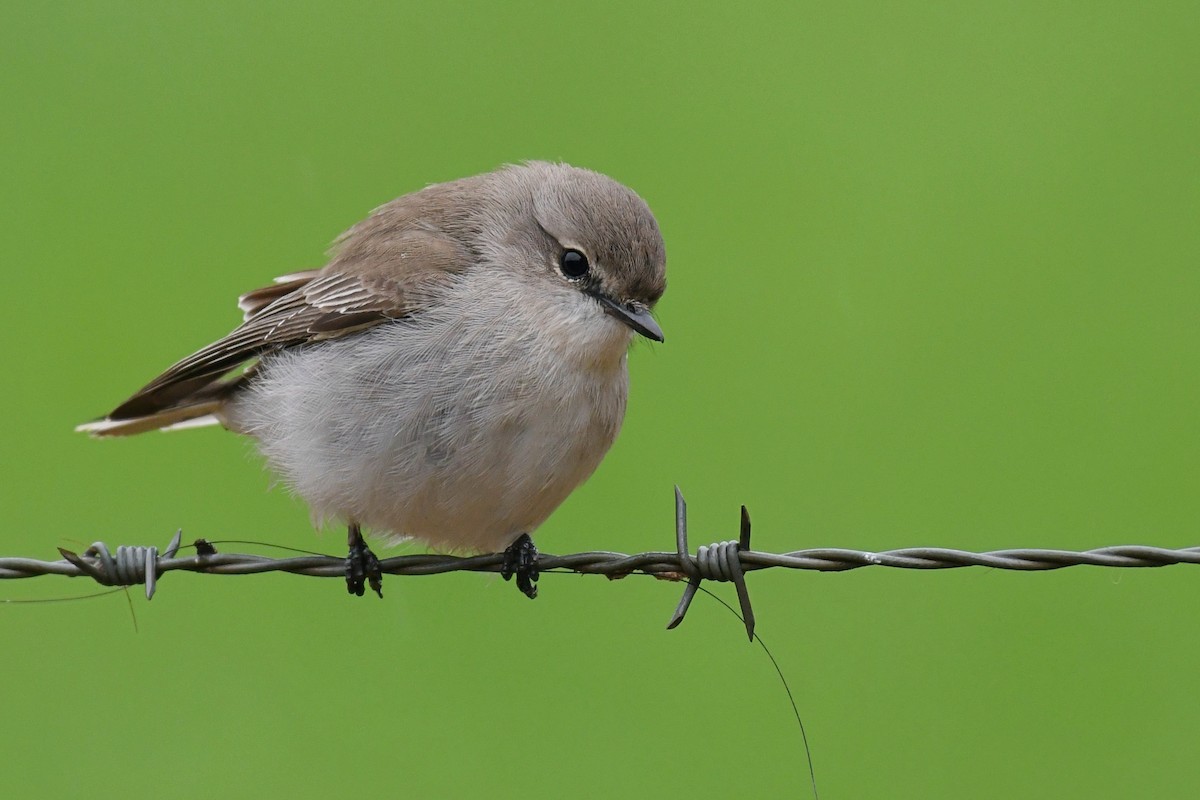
[107,226,468,420]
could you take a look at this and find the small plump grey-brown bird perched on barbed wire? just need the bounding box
[77,161,666,599]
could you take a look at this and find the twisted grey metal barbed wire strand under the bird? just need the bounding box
[0,487,1200,640]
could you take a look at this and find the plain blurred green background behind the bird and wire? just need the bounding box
[0,1,1200,800]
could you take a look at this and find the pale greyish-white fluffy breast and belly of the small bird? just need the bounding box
[223,273,630,551]
